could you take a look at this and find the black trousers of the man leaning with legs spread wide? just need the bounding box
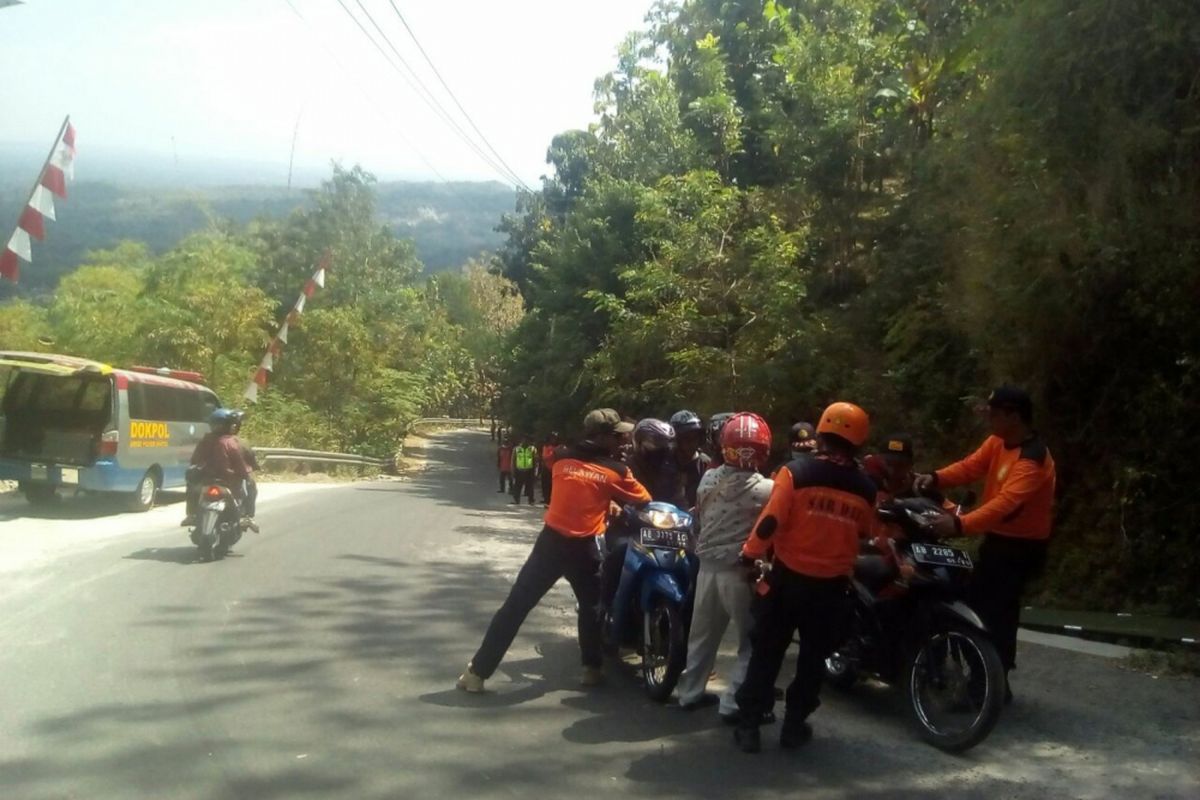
[470,528,604,678]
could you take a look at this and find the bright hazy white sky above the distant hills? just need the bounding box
[0,0,652,184]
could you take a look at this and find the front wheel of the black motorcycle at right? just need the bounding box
[902,625,1004,753]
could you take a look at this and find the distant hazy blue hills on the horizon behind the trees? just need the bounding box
[0,148,515,297]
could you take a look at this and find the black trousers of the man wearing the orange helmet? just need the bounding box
[736,568,852,726]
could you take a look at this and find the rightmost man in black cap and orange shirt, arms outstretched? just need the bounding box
[914,386,1057,702]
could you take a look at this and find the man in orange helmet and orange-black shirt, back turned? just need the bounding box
[734,403,875,753]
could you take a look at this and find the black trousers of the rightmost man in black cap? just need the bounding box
[970,534,1048,672]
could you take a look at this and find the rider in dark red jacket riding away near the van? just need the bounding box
[180,408,258,533]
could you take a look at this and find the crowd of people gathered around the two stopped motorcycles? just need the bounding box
[472,386,1056,752]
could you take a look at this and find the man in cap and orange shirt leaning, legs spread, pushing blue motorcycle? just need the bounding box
[457,408,650,692]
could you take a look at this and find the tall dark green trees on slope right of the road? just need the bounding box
[498,0,1200,615]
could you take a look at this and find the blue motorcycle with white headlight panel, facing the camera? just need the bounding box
[604,503,698,703]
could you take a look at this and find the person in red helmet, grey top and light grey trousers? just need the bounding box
[679,413,773,723]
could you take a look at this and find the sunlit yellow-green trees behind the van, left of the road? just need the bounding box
[0,167,523,456]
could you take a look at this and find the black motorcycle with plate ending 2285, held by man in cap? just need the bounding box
[826,498,1007,752]
